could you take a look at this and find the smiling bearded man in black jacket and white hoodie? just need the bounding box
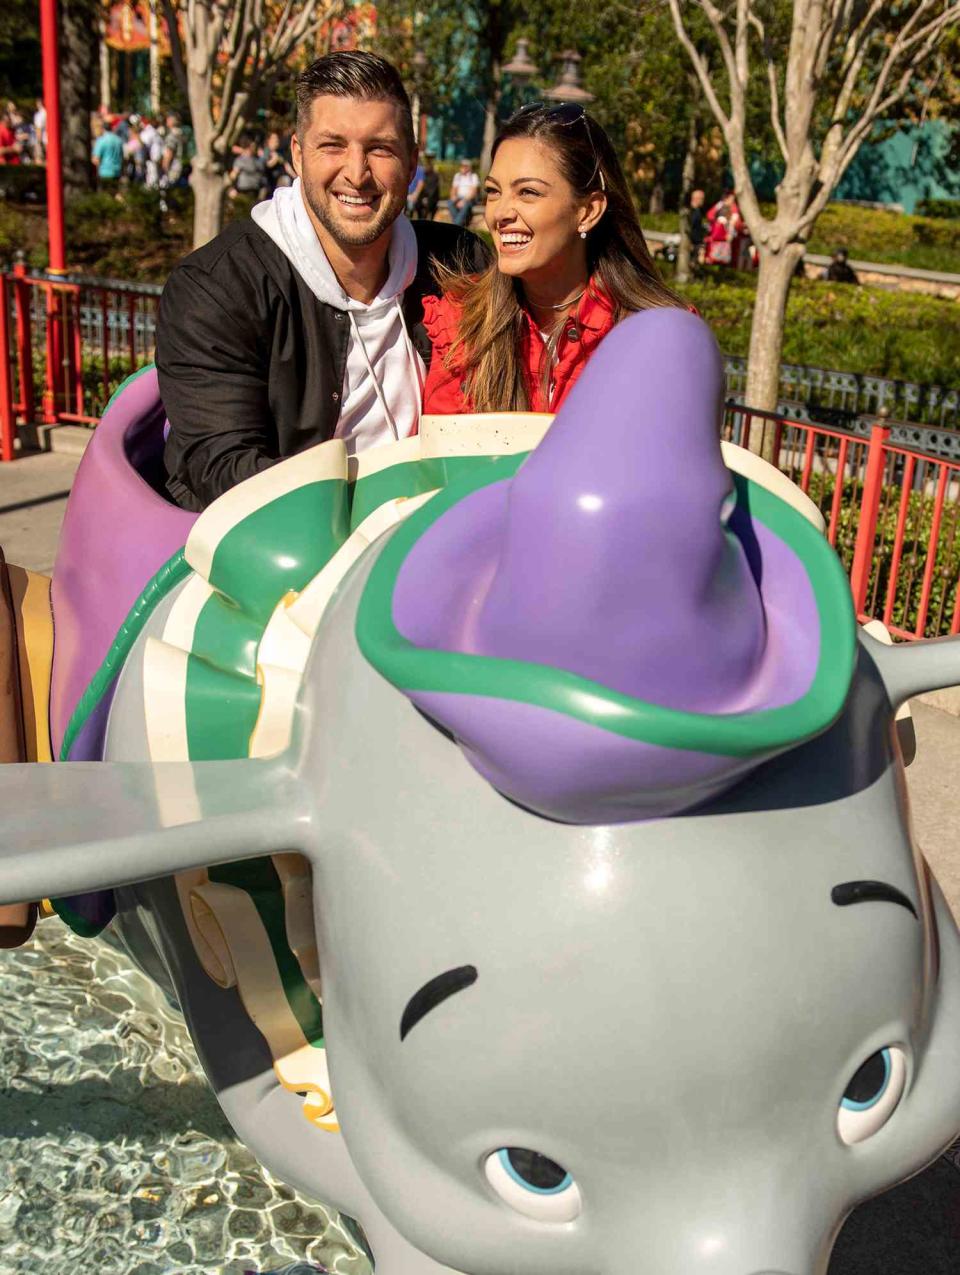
[157,50,486,509]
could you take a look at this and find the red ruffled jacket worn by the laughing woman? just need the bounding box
[423,282,615,416]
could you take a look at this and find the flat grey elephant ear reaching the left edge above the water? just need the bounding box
[0,760,310,903]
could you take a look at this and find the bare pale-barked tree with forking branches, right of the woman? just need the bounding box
[668,0,960,418]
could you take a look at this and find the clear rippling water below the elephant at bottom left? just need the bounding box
[0,919,370,1275]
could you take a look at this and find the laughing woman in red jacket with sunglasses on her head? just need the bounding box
[423,105,683,413]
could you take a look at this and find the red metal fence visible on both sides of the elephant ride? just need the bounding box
[0,265,960,638]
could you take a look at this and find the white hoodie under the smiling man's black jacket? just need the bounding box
[251,177,426,455]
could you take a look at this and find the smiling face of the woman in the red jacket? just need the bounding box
[483,138,602,278]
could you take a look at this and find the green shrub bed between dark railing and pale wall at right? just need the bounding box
[683,270,960,388]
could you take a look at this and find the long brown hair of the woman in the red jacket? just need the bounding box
[435,105,686,412]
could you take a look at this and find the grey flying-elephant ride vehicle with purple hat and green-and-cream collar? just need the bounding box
[0,310,960,1275]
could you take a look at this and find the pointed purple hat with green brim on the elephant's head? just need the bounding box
[357,309,855,824]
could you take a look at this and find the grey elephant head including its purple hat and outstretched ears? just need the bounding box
[0,314,960,1275]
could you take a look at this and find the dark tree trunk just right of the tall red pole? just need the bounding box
[60,0,99,198]
